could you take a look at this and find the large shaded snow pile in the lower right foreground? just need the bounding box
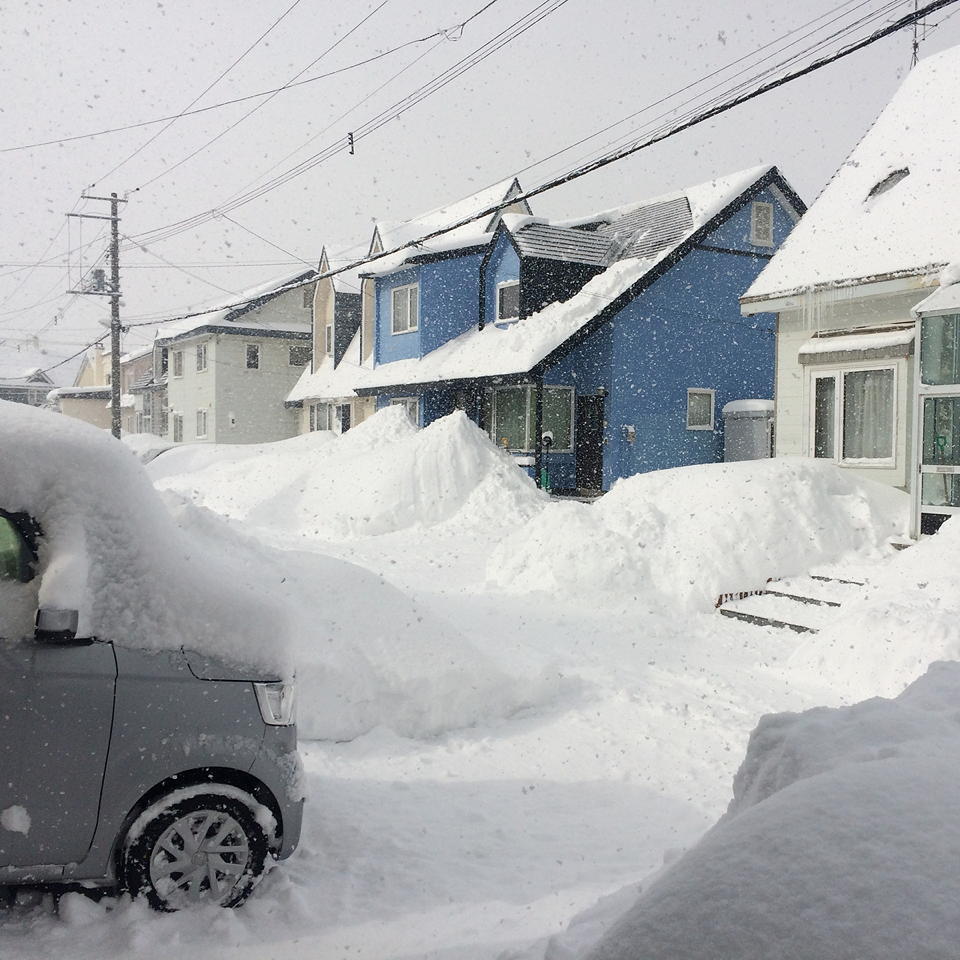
[572,663,960,960]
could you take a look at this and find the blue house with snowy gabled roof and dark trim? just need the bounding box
[306,167,805,491]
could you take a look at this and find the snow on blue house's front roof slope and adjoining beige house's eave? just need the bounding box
[288,166,788,401]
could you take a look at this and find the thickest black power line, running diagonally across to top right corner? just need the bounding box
[122,0,958,336]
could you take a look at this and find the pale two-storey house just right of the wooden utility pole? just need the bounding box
[154,270,316,443]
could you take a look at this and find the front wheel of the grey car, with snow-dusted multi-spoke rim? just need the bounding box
[122,784,269,912]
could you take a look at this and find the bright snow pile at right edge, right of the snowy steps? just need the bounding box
[791,519,960,699]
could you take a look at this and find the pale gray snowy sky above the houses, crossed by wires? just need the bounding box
[0,0,960,376]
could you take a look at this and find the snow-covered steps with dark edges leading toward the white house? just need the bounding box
[719,574,864,633]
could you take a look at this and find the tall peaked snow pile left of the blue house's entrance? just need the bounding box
[154,406,543,540]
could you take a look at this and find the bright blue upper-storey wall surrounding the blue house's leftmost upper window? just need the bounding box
[376,253,483,363]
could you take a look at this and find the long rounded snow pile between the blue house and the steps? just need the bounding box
[487,458,909,610]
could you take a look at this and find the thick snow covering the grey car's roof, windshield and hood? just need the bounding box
[0,401,290,671]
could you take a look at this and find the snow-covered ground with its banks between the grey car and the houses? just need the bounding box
[0,410,958,960]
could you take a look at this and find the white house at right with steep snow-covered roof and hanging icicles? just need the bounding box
[741,48,960,506]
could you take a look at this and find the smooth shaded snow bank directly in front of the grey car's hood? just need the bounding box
[166,494,557,740]
